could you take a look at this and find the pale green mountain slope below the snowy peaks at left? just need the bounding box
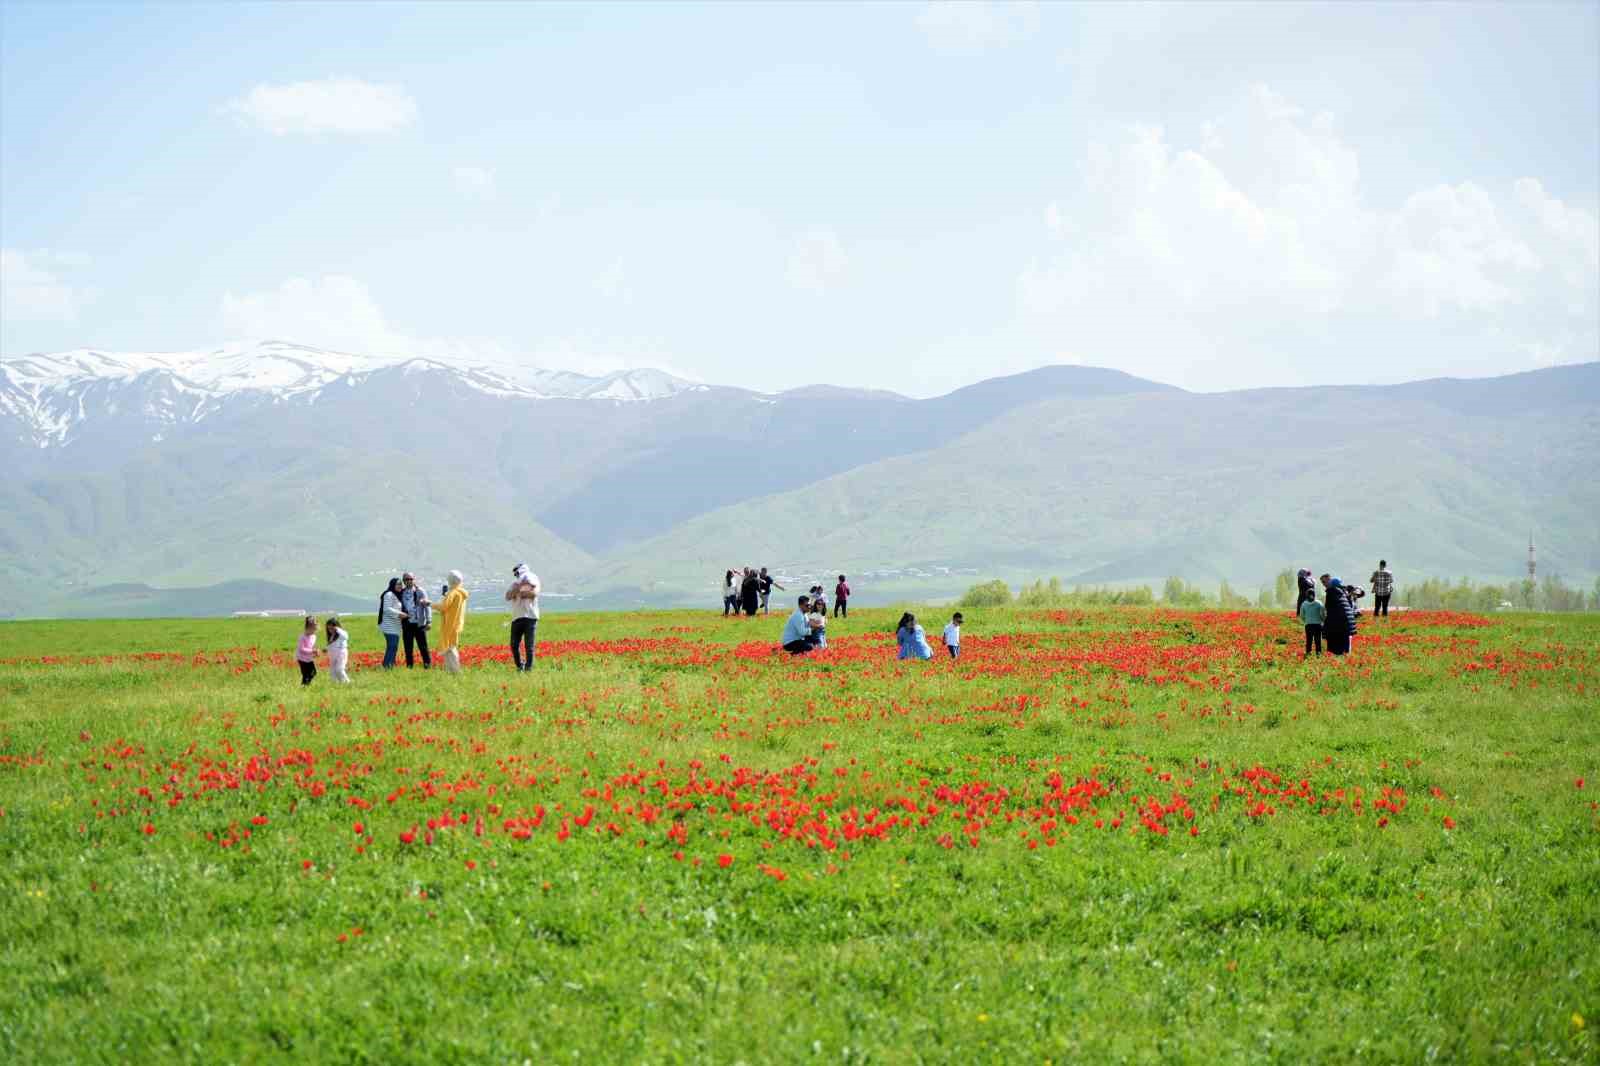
[0,443,594,594]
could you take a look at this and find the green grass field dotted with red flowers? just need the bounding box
[0,608,1600,1063]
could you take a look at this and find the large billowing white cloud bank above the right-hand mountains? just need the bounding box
[1018,88,1600,389]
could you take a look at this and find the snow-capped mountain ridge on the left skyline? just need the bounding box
[0,341,706,448]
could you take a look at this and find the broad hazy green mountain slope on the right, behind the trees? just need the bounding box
[595,363,1600,602]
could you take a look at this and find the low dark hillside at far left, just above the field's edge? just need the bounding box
[14,581,378,618]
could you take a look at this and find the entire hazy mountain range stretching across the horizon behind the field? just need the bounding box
[0,344,1600,613]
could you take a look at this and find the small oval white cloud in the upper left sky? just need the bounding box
[222,77,418,136]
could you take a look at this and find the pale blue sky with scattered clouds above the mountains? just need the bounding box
[0,0,1600,395]
